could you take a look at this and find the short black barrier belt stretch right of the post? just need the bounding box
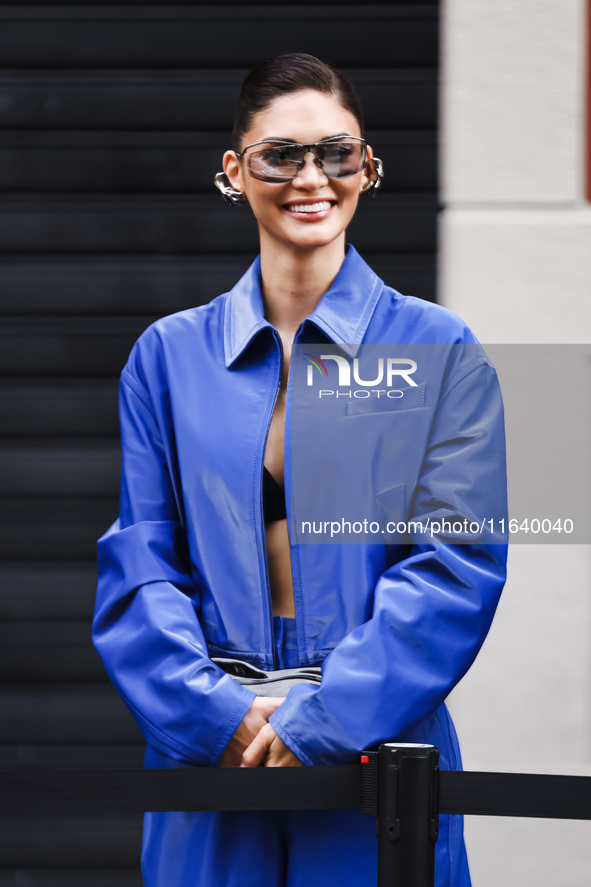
[439,770,591,819]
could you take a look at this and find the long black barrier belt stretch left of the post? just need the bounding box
[0,765,361,814]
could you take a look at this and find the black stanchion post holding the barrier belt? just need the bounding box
[377,742,439,887]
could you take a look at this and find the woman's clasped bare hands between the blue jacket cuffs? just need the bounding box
[218,696,304,767]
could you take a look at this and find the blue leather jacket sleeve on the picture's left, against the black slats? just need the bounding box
[93,370,254,765]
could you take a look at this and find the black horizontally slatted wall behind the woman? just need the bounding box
[0,0,438,887]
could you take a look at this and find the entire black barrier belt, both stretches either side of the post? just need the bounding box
[0,765,591,819]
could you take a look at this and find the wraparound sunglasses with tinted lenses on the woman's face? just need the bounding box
[236,136,367,182]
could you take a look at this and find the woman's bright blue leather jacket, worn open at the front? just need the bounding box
[93,246,506,767]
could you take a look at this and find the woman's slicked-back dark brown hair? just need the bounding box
[232,52,363,151]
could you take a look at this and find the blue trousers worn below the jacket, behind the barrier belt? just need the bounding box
[142,617,470,887]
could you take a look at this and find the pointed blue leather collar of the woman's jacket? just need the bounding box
[224,244,384,367]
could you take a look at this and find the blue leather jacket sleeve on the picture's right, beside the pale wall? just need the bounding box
[270,364,507,764]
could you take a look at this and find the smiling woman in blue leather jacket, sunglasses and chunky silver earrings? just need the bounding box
[94,54,505,887]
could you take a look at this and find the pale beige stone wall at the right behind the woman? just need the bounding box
[440,0,591,887]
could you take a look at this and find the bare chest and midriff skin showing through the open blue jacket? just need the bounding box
[265,348,295,616]
